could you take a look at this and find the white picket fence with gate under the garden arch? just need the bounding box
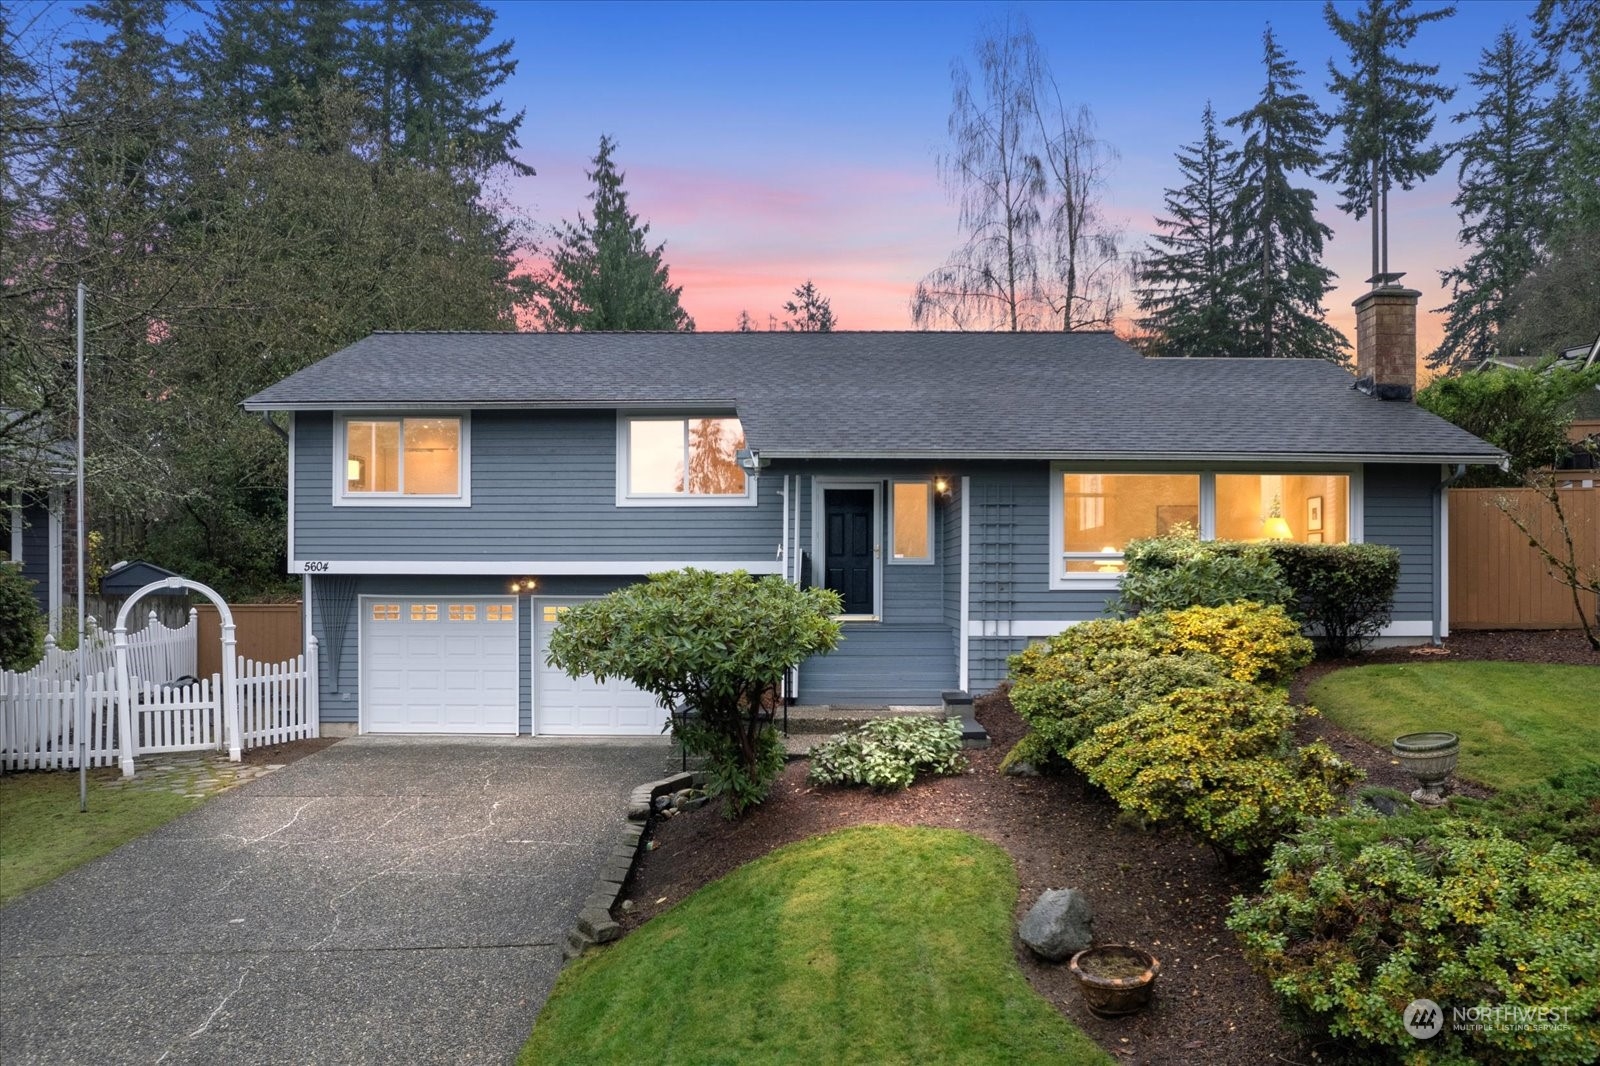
[0,633,318,770]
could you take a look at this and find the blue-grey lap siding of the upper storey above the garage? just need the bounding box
[293,411,782,562]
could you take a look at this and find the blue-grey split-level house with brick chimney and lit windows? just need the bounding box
[245,290,1502,735]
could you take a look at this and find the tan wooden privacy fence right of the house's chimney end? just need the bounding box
[1450,488,1600,629]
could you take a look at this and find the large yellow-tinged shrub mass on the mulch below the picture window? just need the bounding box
[1011,603,1357,855]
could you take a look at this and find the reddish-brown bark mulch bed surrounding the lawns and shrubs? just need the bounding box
[619,632,1600,1064]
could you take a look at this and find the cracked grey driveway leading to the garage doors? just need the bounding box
[0,738,677,1066]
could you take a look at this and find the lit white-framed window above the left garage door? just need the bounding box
[336,415,470,506]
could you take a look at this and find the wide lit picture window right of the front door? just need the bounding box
[1050,466,1357,589]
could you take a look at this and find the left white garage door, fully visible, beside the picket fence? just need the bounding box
[362,597,520,733]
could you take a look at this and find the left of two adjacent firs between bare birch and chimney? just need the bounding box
[1136,101,1238,355]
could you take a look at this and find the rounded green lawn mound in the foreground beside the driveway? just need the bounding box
[520,826,1112,1066]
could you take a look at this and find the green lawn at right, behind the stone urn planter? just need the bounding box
[1306,663,1600,789]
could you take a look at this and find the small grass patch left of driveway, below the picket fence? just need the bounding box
[0,770,200,903]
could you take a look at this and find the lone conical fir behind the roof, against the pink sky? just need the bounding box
[536,136,694,331]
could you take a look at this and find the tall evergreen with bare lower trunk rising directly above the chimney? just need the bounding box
[1322,0,1456,277]
